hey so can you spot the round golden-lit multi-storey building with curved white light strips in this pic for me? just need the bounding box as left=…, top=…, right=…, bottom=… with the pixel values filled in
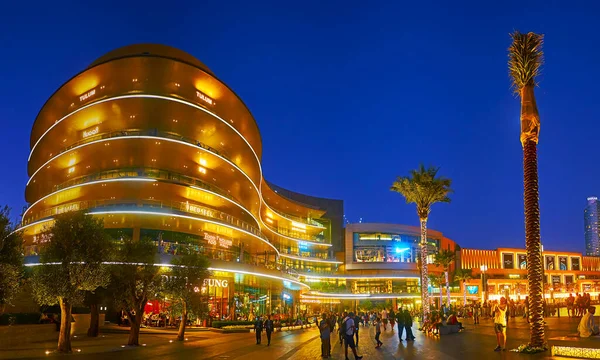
left=21, top=44, right=341, bottom=318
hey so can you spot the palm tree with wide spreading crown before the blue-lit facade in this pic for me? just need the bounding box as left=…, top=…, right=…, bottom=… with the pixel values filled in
left=390, top=164, right=452, bottom=321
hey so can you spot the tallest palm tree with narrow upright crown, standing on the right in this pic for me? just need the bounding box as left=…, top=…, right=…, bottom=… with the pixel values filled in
left=508, top=31, right=546, bottom=348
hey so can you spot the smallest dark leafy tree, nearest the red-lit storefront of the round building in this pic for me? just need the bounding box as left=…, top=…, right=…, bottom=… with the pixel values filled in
left=165, top=251, right=210, bottom=341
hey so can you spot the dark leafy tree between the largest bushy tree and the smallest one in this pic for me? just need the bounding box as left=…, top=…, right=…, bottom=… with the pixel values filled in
left=111, top=238, right=162, bottom=346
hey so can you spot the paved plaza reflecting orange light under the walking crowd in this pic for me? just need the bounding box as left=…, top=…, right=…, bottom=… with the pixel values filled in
left=0, top=317, right=592, bottom=360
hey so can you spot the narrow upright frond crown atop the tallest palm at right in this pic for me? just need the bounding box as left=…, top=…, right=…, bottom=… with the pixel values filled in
left=508, top=31, right=544, bottom=93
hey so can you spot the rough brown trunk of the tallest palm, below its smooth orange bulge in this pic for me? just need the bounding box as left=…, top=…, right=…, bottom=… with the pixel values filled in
left=523, top=140, right=546, bottom=347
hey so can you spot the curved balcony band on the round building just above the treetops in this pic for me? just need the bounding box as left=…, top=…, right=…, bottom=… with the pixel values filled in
left=22, top=200, right=270, bottom=243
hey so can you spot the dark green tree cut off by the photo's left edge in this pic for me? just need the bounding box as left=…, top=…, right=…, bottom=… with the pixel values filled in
left=0, top=206, right=23, bottom=315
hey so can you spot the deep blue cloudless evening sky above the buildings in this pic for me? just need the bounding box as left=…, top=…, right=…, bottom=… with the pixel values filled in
left=0, top=1, right=600, bottom=251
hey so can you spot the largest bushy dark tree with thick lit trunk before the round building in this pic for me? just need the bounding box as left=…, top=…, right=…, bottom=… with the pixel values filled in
left=32, top=211, right=112, bottom=352
